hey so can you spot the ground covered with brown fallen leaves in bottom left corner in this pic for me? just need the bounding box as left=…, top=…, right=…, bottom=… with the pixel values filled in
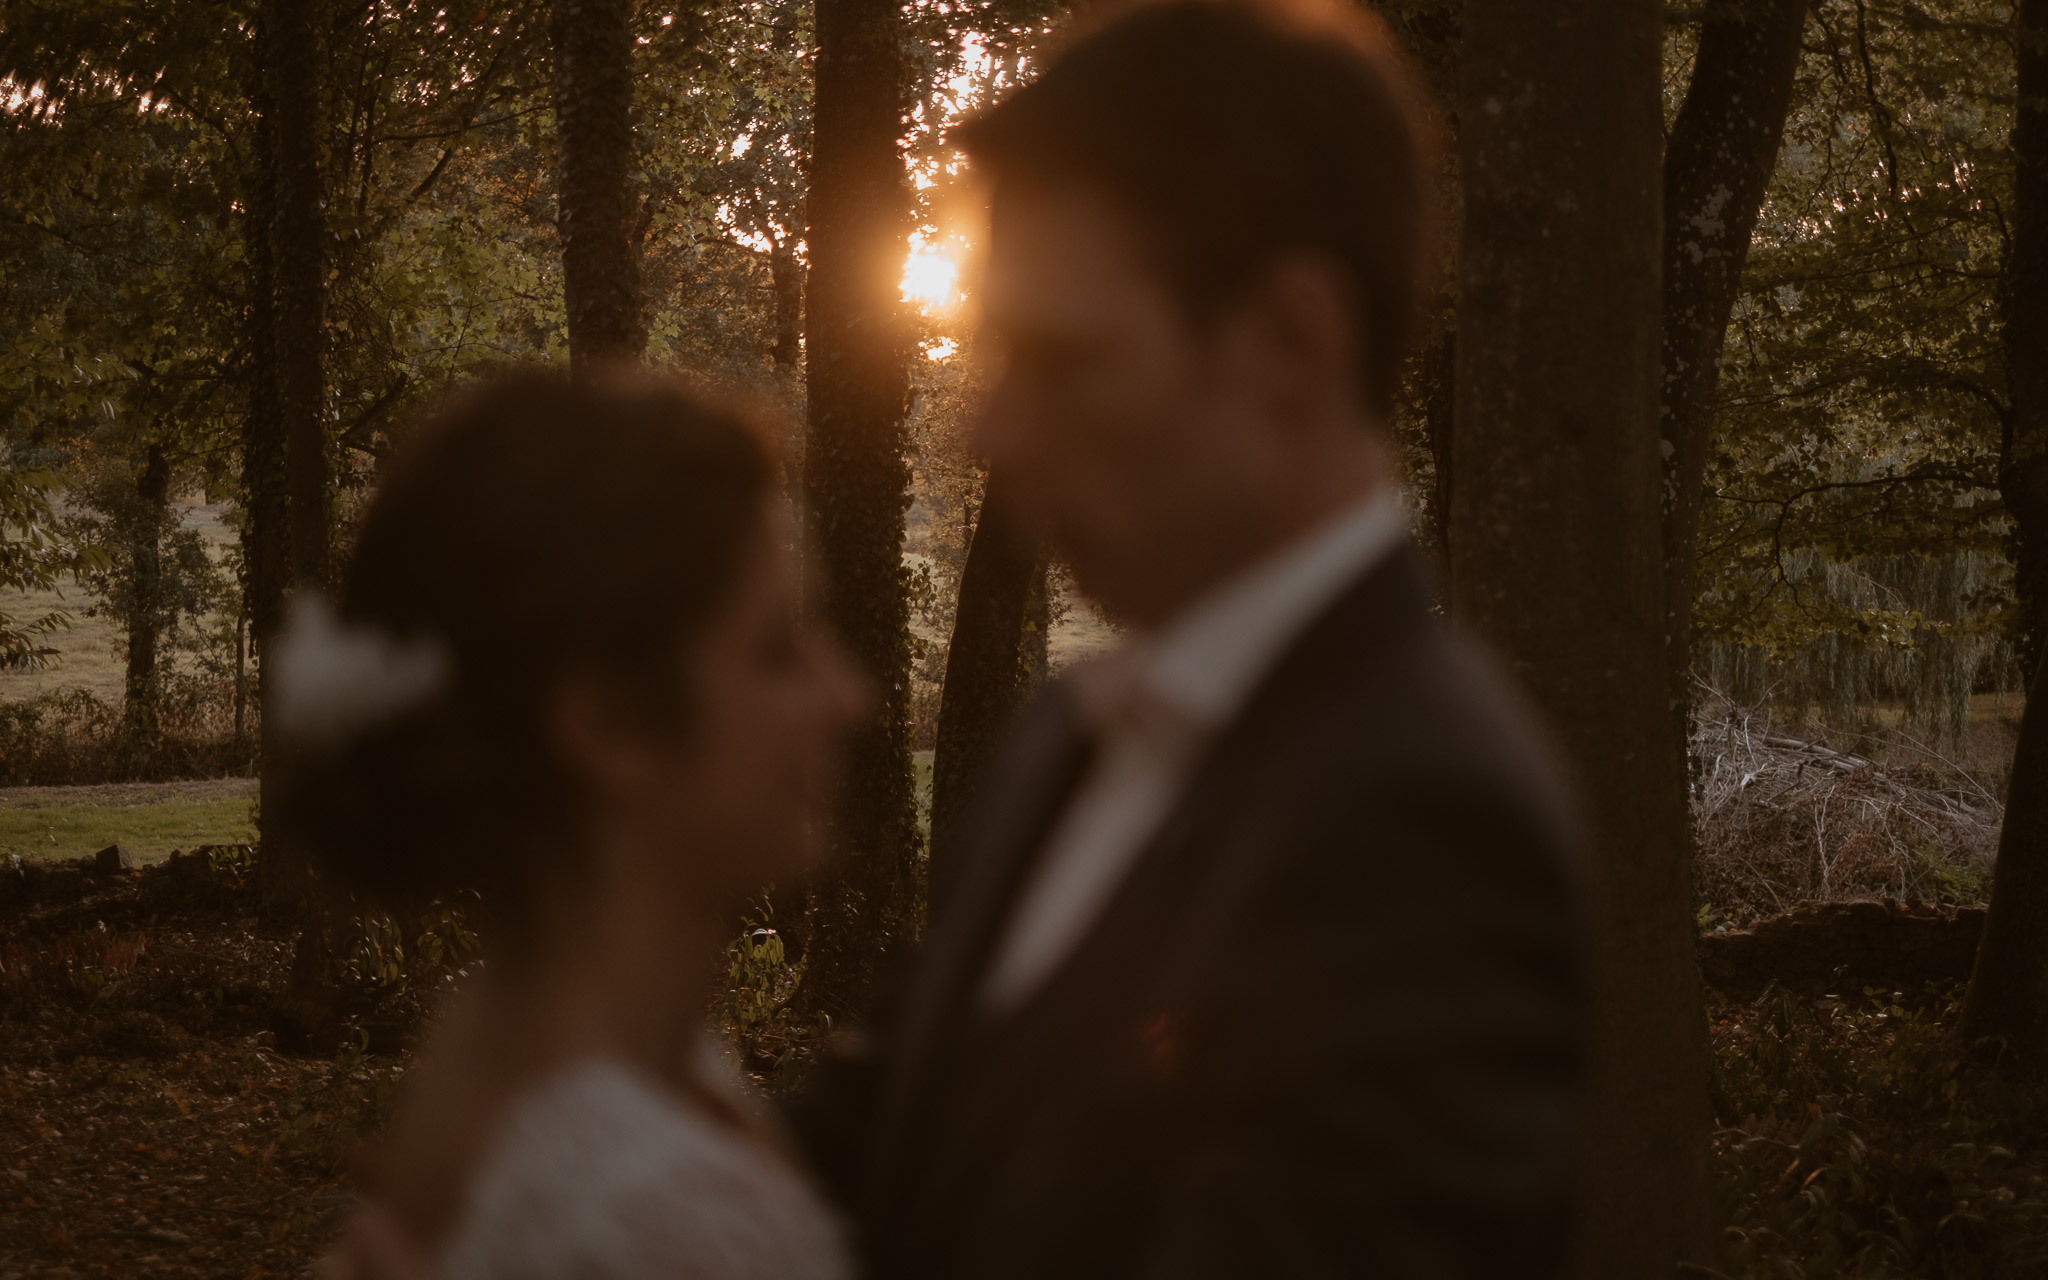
left=0, top=851, right=403, bottom=1280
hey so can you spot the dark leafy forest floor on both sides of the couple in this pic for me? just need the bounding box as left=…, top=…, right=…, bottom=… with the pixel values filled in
left=0, top=856, right=2048, bottom=1280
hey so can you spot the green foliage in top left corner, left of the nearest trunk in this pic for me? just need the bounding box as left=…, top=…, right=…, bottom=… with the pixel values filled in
left=0, top=0, right=246, bottom=491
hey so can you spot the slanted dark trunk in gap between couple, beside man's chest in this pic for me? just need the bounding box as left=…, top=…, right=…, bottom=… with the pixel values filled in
left=932, top=471, right=1044, bottom=895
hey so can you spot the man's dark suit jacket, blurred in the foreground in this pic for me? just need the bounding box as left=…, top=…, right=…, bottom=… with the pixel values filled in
left=793, top=547, right=1581, bottom=1280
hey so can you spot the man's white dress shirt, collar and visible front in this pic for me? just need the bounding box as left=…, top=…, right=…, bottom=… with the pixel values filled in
left=981, top=492, right=1407, bottom=1012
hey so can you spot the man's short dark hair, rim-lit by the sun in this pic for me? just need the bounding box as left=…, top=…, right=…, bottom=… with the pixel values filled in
left=956, top=0, right=1434, bottom=416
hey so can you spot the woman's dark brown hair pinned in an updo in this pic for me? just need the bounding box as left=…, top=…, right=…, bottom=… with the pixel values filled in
left=279, top=373, right=774, bottom=926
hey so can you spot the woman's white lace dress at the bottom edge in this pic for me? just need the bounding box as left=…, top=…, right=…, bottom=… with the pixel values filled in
left=440, top=1061, right=854, bottom=1280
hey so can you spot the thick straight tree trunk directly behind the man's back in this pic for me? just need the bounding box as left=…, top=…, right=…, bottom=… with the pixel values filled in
left=1452, top=0, right=1714, bottom=1278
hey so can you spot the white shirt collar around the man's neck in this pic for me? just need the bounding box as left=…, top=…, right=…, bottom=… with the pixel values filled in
left=1143, top=489, right=1407, bottom=729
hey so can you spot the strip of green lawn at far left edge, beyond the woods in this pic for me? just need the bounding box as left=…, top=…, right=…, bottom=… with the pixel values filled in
left=0, top=778, right=256, bottom=862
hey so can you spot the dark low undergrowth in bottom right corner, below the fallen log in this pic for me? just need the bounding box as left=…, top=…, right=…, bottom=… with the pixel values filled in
left=1712, top=987, right=2048, bottom=1280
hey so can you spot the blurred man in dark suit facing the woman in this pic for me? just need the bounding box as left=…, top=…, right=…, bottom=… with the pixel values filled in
left=797, top=0, right=1581, bottom=1280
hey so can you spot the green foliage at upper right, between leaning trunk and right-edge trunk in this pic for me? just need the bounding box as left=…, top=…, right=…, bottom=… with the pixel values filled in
left=1671, top=0, right=2017, bottom=733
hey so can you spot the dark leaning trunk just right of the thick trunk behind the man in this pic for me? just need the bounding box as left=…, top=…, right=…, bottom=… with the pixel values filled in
left=1661, top=0, right=1810, bottom=700
